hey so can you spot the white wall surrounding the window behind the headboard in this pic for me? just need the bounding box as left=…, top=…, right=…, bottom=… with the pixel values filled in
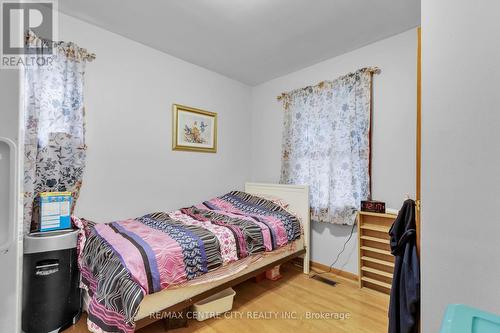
left=251, top=29, right=417, bottom=274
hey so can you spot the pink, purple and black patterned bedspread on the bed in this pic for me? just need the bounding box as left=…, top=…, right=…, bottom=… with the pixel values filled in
left=75, top=191, right=301, bottom=332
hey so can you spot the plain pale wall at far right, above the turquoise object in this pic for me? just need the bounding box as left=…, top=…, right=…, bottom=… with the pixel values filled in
left=422, top=0, right=500, bottom=332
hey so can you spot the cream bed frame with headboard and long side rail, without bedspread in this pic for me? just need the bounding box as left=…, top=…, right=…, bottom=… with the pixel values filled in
left=79, top=183, right=310, bottom=332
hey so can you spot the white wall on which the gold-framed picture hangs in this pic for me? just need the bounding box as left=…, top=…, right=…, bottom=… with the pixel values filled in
left=59, top=14, right=251, bottom=221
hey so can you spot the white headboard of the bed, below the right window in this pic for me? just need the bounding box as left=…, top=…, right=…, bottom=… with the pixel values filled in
left=245, top=183, right=311, bottom=274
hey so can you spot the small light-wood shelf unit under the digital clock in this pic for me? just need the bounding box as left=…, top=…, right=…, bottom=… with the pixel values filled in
left=358, top=212, right=397, bottom=294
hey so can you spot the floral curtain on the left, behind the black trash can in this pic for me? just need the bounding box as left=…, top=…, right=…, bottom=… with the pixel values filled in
left=24, top=32, right=95, bottom=233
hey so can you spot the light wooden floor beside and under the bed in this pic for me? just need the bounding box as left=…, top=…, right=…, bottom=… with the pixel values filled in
left=65, top=264, right=389, bottom=333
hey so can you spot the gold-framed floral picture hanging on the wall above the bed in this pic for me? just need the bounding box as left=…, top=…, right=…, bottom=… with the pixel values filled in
left=172, top=104, right=217, bottom=153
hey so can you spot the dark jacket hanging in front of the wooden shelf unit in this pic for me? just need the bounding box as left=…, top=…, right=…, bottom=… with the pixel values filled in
left=389, top=200, right=420, bottom=333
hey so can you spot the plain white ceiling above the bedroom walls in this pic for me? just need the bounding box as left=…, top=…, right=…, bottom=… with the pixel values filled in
left=59, top=0, right=420, bottom=85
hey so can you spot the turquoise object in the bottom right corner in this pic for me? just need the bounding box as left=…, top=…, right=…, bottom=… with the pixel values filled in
left=440, top=304, right=500, bottom=333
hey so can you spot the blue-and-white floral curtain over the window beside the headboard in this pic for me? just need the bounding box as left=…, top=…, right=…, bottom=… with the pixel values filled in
left=281, top=68, right=376, bottom=225
